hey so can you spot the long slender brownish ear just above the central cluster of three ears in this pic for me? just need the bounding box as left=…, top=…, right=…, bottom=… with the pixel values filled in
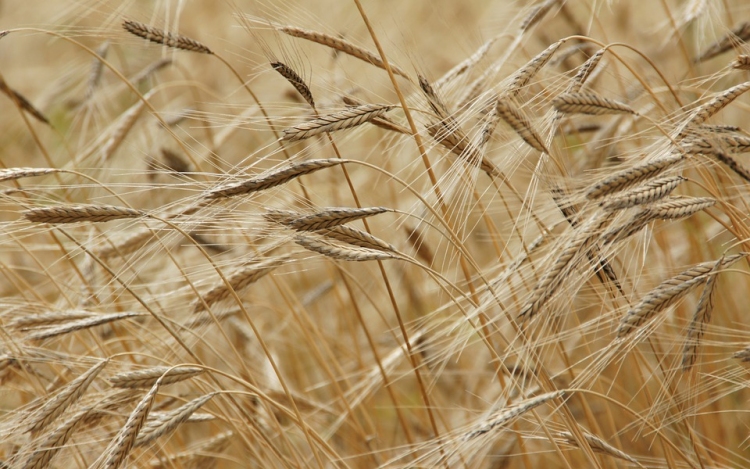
left=206, top=158, right=346, bottom=199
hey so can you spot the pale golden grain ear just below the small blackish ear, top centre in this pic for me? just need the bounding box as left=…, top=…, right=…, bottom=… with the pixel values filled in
left=282, top=104, right=393, bottom=142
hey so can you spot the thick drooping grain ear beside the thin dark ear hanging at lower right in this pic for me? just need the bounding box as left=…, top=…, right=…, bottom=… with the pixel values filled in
left=617, top=253, right=747, bottom=338
